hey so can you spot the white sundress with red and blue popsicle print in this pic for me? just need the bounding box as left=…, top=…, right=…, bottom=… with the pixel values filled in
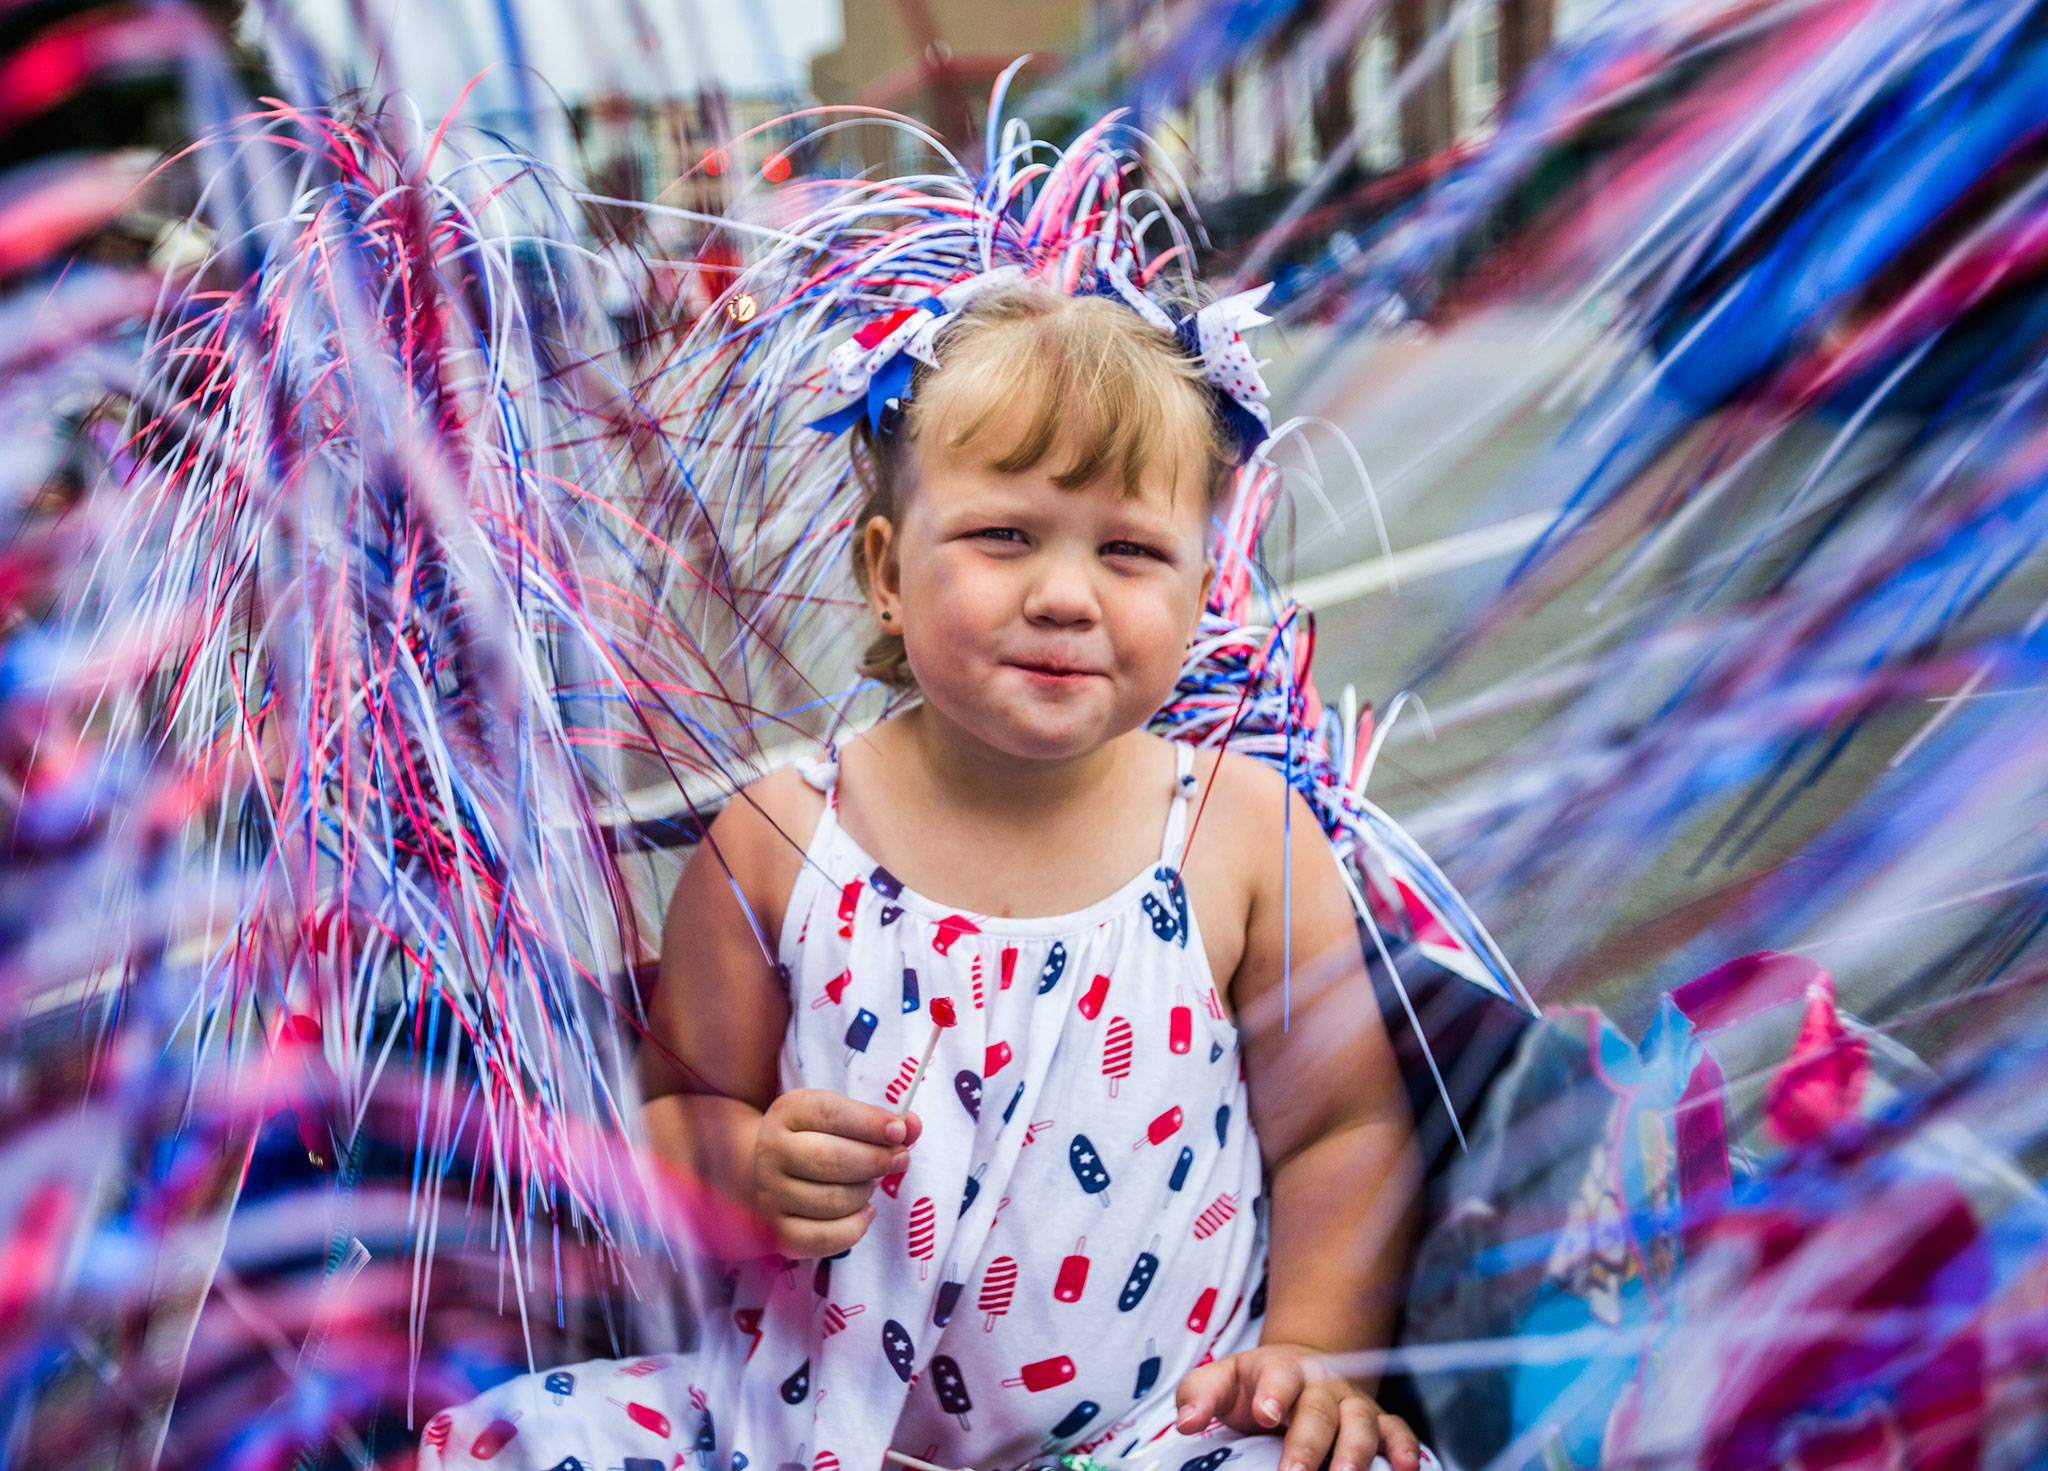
left=422, top=746, right=1433, bottom=1471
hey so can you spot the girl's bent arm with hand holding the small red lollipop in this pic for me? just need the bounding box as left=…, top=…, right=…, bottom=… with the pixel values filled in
left=641, top=772, right=918, bottom=1256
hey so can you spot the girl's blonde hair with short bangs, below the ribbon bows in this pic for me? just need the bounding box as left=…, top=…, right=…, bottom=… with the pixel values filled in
left=852, top=283, right=1237, bottom=690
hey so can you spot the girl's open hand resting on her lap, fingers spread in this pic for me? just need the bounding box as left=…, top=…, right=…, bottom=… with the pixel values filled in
left=1176, top=1344, right=1421, bottom=1471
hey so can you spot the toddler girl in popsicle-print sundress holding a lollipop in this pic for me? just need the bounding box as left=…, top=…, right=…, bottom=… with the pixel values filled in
left=424, top=115, right=1434, bottom=1471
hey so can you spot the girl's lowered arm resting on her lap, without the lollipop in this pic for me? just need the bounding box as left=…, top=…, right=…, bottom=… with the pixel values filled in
left=1180, top=762, right=1419, bottom=1471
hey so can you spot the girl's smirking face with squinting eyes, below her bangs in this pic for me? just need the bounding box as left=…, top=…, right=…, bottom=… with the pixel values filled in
left=866, top=424, right=1210, bottom=760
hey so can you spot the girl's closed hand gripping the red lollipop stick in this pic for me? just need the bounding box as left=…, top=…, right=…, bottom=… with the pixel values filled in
left=754, top=1088, right=924, bottom=1258
